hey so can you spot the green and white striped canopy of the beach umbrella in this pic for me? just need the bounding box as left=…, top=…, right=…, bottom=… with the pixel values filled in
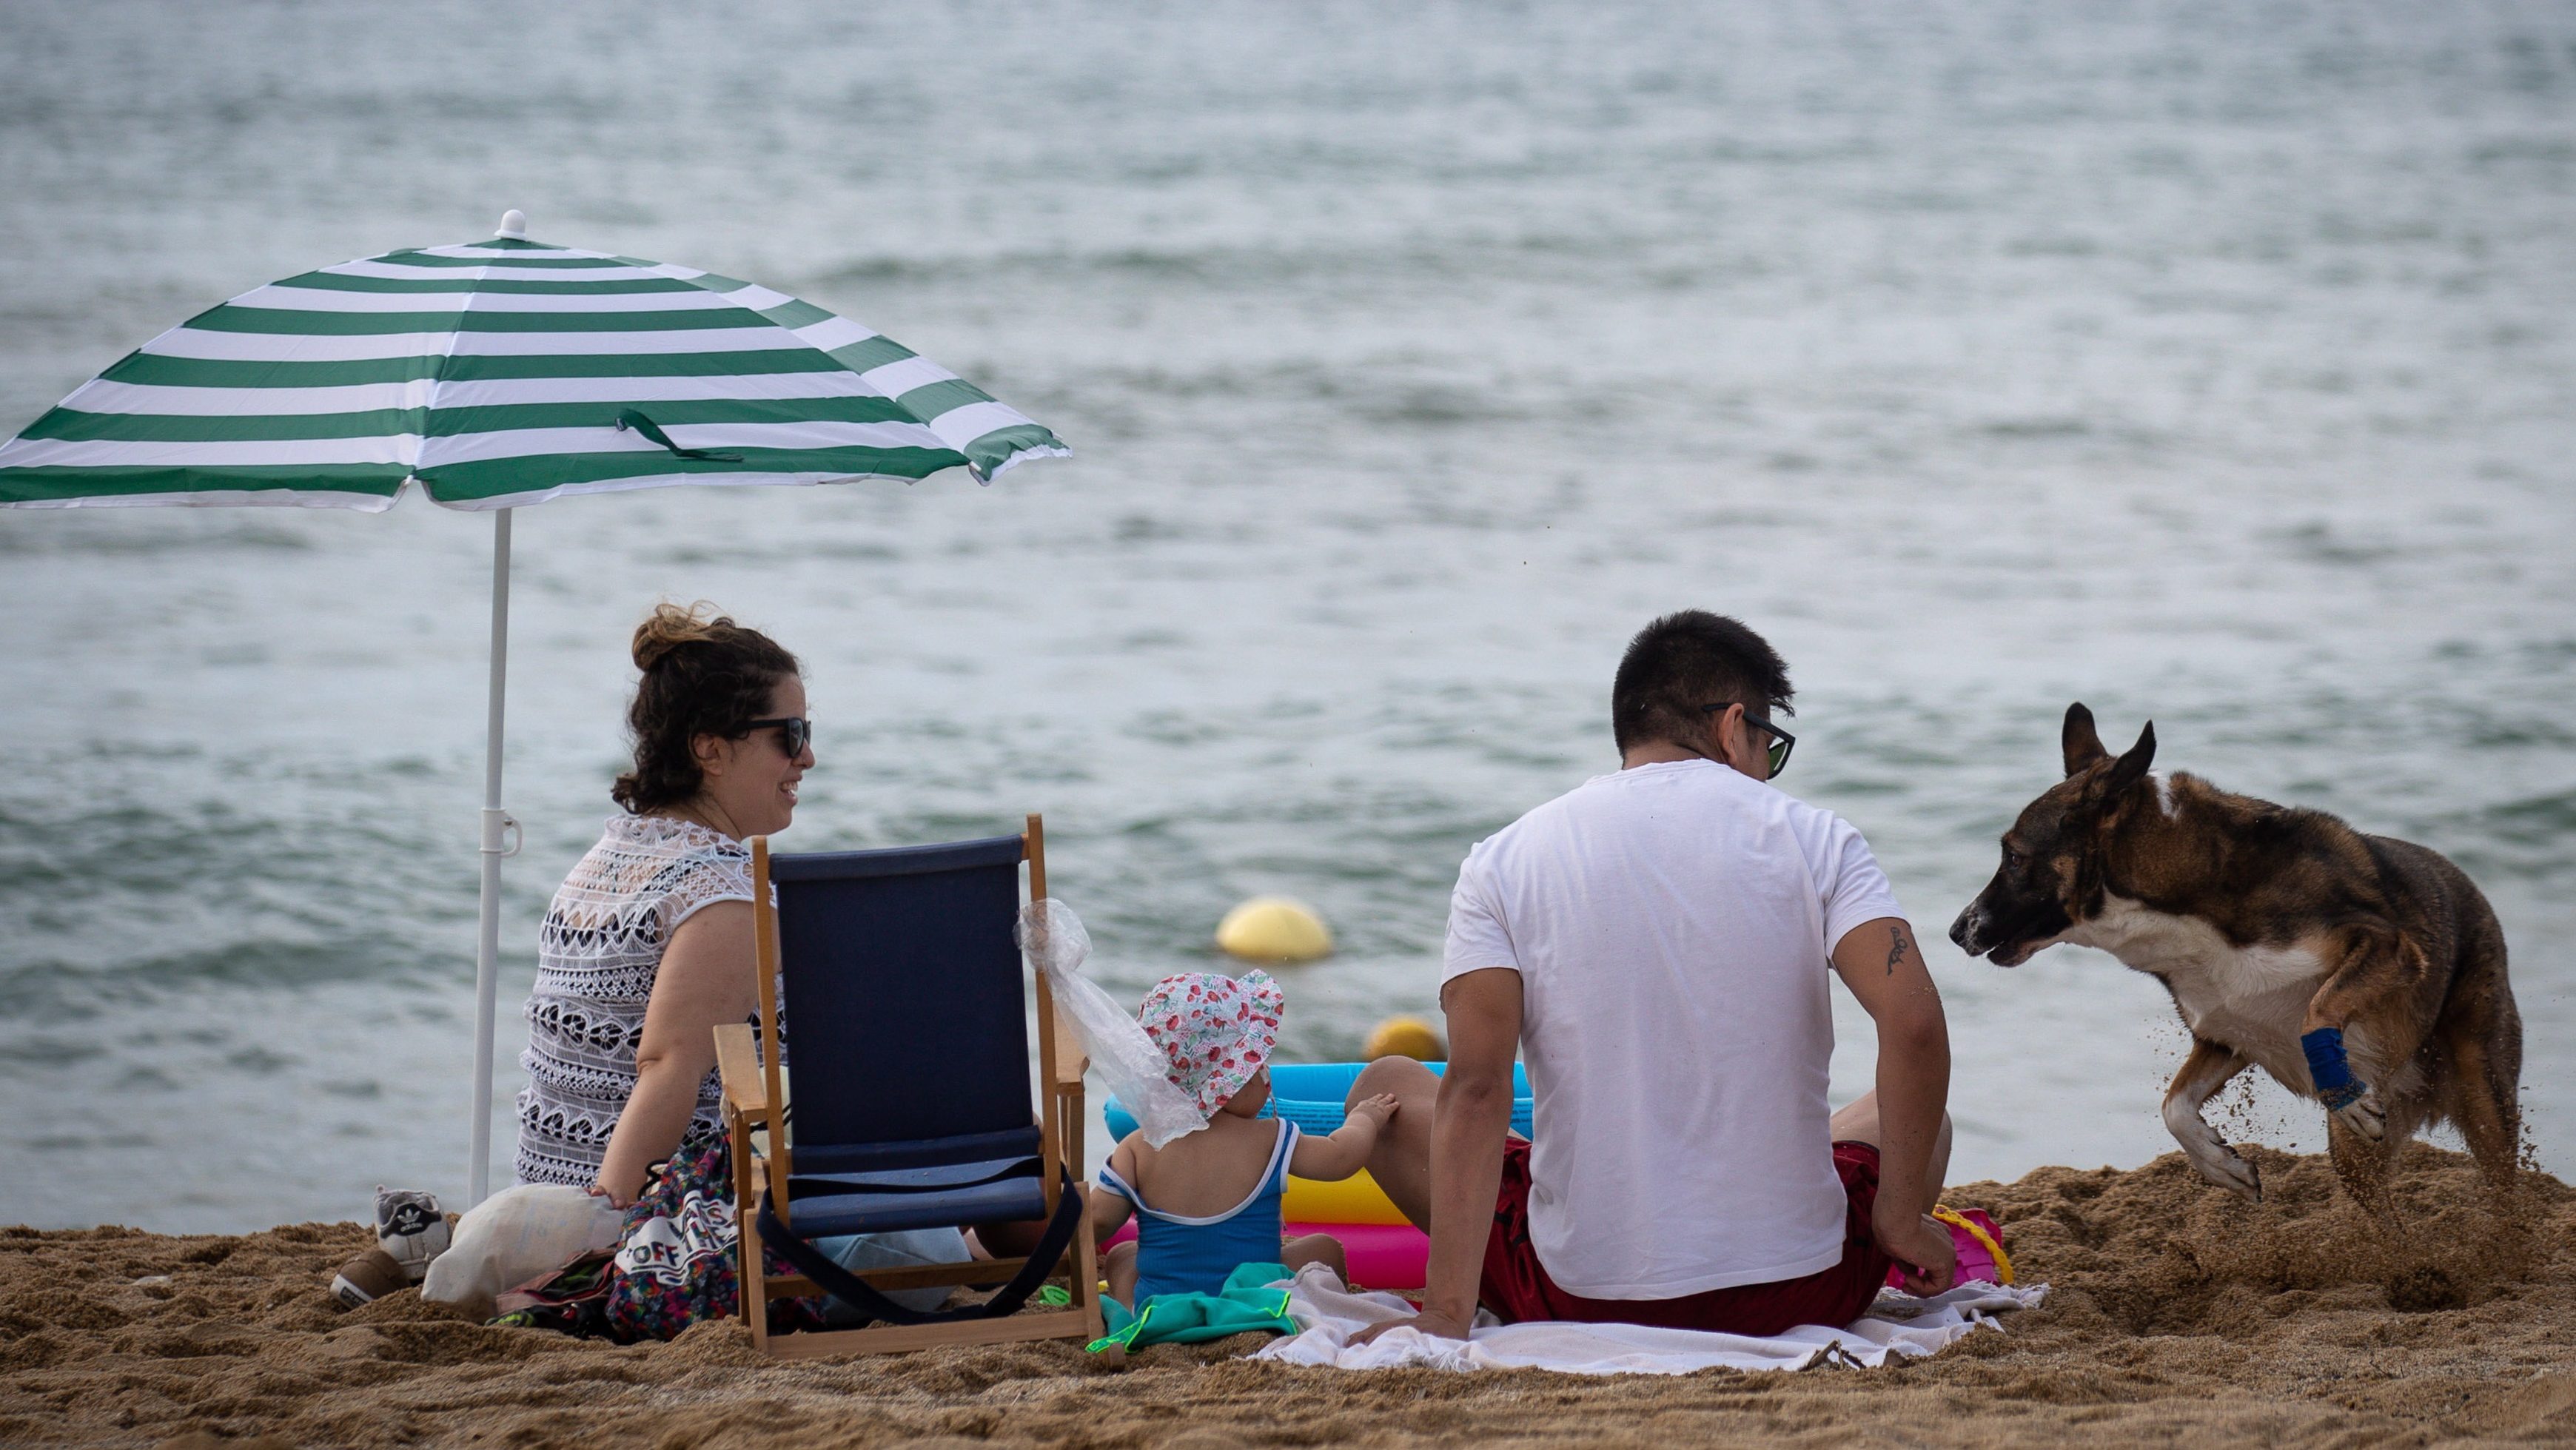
left=0, top=237, right=1069, bottom=510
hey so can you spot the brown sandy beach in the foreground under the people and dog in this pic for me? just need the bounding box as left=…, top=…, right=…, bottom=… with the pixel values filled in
left=0, top=1146, right=2576, bottom=1450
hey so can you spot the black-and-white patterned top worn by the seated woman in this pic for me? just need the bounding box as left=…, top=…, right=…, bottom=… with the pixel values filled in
left=517, top=816, right=752, bottom=1185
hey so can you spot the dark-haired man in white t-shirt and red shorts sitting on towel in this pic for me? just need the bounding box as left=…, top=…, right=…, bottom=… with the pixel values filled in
left=1352, top=611, right=1955, bottom=1337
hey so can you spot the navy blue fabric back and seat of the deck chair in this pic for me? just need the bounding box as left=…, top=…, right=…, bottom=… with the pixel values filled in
left=771, top=837, right=1046, bottom=1236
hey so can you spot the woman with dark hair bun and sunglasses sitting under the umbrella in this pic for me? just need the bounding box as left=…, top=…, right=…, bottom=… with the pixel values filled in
left=517, top=603, right=814, bottom=1208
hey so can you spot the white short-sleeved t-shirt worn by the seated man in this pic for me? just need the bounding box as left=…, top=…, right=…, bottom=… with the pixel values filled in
left=1440, top=759, right=1904, bottom=1298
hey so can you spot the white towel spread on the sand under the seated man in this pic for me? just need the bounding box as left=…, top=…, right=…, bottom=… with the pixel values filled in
left=1252, top=1264, right=2048, bottom=1375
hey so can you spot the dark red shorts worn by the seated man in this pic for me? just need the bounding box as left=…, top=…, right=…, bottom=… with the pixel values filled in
left=1476, top=1138, right=1888, bottom=1334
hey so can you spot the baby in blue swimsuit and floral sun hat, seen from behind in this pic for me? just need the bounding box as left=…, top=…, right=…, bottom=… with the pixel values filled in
left=1093, top=971, right=1396, bottom=1306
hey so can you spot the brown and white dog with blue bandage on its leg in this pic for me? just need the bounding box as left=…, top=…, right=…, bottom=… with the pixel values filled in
left=1950, top=705, right=2522, bottom=1210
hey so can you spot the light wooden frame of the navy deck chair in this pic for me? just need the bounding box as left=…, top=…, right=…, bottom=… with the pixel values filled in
left=716, top=816, right=1105, bottom=1360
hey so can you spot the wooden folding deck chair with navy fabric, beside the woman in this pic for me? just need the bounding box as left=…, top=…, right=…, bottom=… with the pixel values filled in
left=716, top=816, right=1102, bottom=1357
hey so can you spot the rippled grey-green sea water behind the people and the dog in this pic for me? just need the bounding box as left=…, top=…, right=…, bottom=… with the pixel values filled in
left=0, top=0, right=2576, bottom=1229
